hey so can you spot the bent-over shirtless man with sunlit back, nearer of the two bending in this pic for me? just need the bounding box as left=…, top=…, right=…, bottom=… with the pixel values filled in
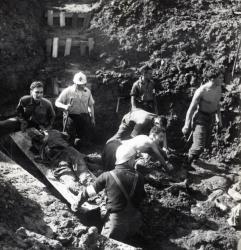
left=101, top=126, right=168, bottom=171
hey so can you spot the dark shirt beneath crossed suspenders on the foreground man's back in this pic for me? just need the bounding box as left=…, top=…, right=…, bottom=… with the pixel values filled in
left=93, top=164, right=146, bottom=213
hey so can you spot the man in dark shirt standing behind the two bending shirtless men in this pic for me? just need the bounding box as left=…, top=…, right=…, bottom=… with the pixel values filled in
left=130, top=65, right=155, bottom=112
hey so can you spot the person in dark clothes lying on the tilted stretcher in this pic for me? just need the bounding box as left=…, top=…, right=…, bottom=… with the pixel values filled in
left=28, top=129, right=91, bottom=193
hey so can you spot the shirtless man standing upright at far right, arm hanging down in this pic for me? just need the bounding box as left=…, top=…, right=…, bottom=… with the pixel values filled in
left=182, top=68, right=223, bottom=166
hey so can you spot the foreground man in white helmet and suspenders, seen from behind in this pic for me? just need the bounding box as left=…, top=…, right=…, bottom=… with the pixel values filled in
left=71, top=145, right=145, bottom=241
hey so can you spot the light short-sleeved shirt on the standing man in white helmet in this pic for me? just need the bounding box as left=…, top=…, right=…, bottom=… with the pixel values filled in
left=58, top=85, right=94, bottom=115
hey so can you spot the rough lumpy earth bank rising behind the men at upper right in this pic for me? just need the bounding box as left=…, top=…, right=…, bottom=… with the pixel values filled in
left=91, top=0, right=241, bottom=161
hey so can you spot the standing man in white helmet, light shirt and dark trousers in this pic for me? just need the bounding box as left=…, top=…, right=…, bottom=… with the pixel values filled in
left=55, top=72, right=95, bottom=145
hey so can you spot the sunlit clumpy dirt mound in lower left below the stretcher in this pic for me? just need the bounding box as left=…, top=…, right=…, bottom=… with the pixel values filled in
left=0, top=153, right=119, bottom=249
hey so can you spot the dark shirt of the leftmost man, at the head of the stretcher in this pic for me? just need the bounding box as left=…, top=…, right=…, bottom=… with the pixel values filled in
left=17, top=95, right=55, bottom=127
